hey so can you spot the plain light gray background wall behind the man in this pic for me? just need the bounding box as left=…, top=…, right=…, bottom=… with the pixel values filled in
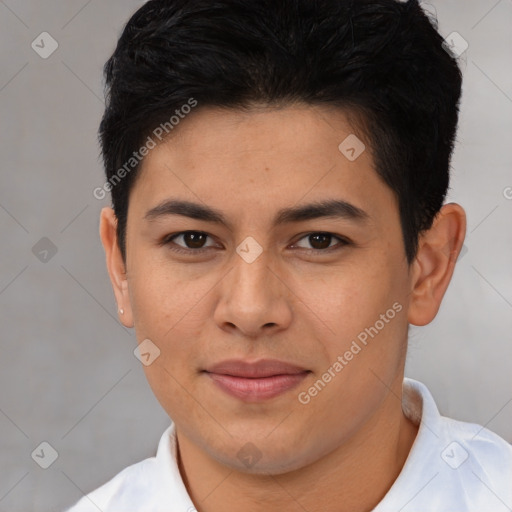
left=0, top=0, right=512, bottom=512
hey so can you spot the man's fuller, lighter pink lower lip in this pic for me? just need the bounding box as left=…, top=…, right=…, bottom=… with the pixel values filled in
left=207, top=372, right=309, bottom=402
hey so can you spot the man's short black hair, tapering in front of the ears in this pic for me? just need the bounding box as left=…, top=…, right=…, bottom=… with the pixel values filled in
left=99, top=0, right=462, bottom=264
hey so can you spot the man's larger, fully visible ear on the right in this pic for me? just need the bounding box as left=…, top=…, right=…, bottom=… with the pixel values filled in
left=408, top=203, right=466, bottom=325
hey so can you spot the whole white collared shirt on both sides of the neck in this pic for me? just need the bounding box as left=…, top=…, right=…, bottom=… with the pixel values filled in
left=67, top=378, right=512, bottom=512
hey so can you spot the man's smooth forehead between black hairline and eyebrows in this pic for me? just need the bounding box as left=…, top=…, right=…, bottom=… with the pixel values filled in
left=130, top=106, right=394, bottom=226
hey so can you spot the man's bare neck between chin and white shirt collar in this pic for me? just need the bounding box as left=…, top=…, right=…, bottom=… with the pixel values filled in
left=177, top=381, right=418, bottom=512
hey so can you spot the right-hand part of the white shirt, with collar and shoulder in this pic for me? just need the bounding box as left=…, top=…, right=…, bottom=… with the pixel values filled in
left=374, top=379, right=512, bottom=512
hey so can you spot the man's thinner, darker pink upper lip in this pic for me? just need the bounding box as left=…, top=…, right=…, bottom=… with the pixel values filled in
left=205, top=359, right=308, bottom=379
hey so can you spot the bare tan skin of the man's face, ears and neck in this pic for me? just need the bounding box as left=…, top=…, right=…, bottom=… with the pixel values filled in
left=100, top=105, right=466, bottom=512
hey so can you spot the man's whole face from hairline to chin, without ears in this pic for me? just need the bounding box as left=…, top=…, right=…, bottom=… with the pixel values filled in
left=119, top=106, right=410, bottom=472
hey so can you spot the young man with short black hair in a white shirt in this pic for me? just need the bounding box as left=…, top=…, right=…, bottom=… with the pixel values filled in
left=71, top=0, right=512, bottom=512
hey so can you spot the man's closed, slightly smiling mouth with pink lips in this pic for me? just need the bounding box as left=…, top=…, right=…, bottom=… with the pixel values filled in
left=204, top=359, right=311, bottom=402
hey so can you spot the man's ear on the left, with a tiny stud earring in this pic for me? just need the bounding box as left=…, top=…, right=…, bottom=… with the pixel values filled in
left=100, top=207, right=133, bottom=327
